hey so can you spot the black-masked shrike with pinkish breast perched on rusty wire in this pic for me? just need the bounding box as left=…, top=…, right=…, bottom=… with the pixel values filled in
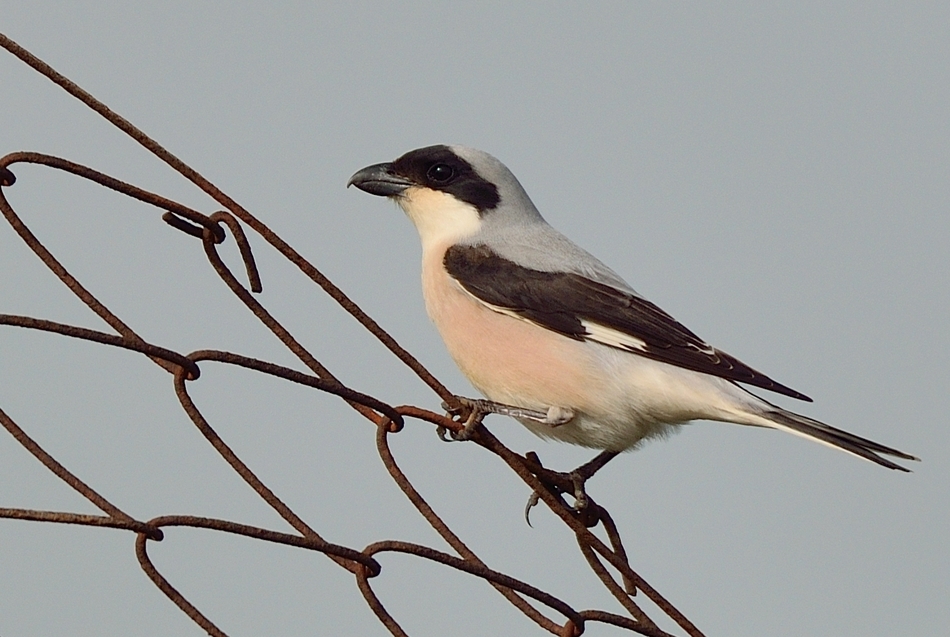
left=349, top=145, right=917, bottom=471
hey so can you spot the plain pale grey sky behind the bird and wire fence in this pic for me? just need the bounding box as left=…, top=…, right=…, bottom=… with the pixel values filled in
left=0, top=0, right=950, bottom=637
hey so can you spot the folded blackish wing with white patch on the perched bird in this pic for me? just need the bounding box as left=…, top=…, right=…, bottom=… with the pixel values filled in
left=444, top=245, right=811, bottom=402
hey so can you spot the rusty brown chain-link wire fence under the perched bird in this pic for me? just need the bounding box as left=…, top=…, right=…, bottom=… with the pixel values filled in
left=0, top=34, right=702, bottom=637
